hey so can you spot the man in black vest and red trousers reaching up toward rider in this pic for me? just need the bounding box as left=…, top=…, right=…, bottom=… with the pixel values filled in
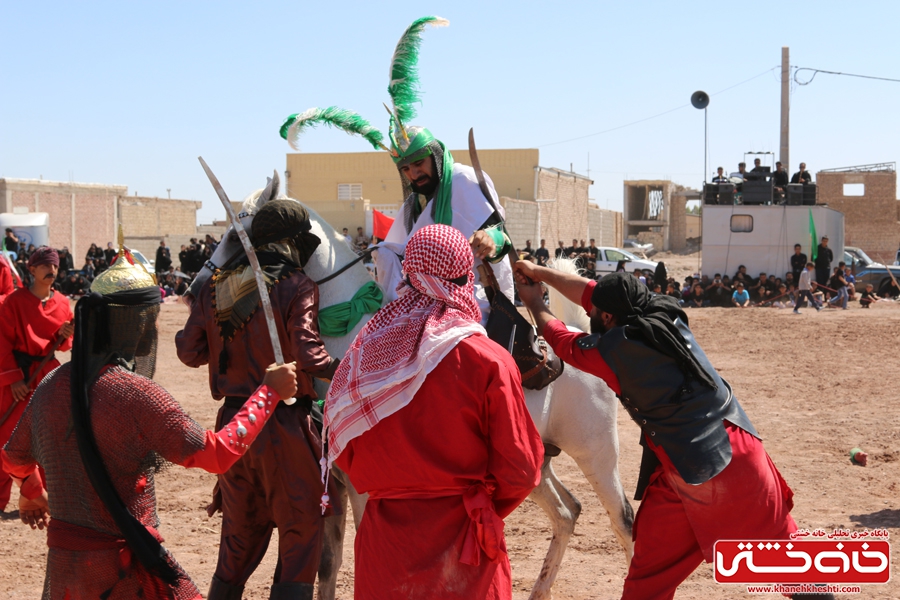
left=516, top=261, right=833, bottom=600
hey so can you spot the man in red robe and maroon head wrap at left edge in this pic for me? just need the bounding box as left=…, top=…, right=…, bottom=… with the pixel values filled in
left=0, top=246, right=74, bottom=510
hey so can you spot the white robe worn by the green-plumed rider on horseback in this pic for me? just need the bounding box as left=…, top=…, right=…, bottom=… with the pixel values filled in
left=375, top=163, right=514, bottom=325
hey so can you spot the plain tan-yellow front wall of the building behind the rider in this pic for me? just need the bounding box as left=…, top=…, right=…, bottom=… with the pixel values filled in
left=287, top=148, right=538, bottom=204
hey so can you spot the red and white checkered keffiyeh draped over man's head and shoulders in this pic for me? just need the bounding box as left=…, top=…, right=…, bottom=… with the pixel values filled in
left=323, top=225, right=486, bottom=469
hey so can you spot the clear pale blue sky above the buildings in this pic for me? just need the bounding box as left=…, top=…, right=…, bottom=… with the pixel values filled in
left=0, top=0, right=900, bottom=222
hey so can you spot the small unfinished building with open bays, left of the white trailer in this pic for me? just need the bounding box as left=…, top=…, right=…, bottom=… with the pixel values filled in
left=623, top=180, right=700, bottom=252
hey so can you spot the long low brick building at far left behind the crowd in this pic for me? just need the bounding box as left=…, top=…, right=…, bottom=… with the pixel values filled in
left=0, top=179, right=202, bottom=268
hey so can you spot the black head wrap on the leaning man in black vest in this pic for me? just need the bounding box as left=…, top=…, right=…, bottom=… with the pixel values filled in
left=591, top=273, right=717, bottom=389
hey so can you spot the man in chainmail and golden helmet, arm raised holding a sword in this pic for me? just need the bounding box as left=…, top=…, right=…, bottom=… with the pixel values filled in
left=2, top=246, right=297, bottom=600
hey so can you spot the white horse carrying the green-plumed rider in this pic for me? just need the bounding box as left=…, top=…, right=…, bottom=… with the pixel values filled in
left=191, top=172, right=634, bottom=600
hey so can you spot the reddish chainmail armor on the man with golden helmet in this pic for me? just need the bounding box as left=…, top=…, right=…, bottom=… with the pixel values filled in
left=7, top=364, right=205, bottom=600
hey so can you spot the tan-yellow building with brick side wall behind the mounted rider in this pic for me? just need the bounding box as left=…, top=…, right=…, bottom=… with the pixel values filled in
left=286, top=148, right=622, bottom=248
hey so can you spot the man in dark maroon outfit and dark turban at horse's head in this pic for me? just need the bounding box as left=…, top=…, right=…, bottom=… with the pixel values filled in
left=175, top=200, right=336, bottom=600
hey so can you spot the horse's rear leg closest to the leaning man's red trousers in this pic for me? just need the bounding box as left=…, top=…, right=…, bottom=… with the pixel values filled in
left=572, top=444, right=634, bottom=566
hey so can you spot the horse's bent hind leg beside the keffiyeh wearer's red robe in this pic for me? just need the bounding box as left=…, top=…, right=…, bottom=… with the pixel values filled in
left=529, top=456, right=581, bottom=600
